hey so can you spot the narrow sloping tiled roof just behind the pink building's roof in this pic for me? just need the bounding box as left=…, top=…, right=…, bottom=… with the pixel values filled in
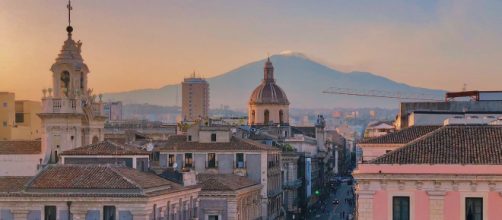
left=359, top=125, right=441, bottom=144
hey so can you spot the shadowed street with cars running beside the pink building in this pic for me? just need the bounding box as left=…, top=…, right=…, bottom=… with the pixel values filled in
left=308, top=183, right=354, bottom=220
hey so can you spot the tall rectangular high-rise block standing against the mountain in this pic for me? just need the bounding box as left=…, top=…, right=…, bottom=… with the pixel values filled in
left=181, top=75, right=209, bottom=121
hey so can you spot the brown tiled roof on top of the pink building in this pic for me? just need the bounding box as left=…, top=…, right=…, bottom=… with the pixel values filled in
left=370, top=125, right=502, bottom=165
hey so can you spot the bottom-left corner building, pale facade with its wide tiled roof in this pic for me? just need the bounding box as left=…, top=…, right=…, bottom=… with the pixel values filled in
left=0, top=165, right=200, bottom=220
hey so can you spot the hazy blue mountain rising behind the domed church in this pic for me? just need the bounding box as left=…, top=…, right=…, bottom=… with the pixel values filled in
left=104, top=53, right=445, bottom=109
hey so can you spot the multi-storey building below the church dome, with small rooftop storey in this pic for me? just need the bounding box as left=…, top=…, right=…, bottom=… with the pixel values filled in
left=154, top=125, right=283, bottom=219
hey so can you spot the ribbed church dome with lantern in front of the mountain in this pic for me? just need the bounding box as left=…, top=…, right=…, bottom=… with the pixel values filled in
left=249, top=58, right=289, bottom=105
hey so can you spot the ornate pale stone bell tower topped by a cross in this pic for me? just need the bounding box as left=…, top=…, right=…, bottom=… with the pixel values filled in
left=39, top=2, right=106, bottom=164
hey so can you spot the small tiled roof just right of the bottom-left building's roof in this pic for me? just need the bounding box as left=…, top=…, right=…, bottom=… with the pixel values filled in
left=197, top=174, right=259, bottom=191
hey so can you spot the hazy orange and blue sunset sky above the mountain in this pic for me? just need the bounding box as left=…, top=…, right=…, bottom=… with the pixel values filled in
left=0, top=0, right=502, bottom=99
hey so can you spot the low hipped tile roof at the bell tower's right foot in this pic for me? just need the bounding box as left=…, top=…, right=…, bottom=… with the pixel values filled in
left=61, top=141, right=150, bottom=155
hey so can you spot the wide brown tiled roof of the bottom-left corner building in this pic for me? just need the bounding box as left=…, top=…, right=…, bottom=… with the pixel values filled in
left=0, top=164, right=194, bottom=197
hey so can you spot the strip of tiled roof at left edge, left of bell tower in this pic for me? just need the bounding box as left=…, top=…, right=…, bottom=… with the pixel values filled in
left=0, top=140, right=42, bottom=154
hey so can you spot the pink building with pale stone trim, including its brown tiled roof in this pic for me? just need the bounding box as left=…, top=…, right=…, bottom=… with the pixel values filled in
left=354, top=125, right=502, bottom=220
